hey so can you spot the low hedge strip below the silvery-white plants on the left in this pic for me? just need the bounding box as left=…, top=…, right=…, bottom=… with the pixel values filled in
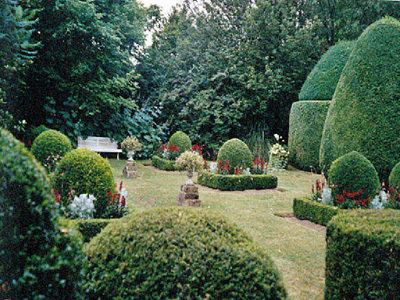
left=59, top=218, right=116, bottom=243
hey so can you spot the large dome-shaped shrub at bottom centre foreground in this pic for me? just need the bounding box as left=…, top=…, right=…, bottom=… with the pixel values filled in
left=85, top=208, right=286, bottom=300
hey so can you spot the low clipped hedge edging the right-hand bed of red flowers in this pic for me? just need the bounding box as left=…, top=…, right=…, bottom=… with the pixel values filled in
left=293, top=198, right=341, bottom=226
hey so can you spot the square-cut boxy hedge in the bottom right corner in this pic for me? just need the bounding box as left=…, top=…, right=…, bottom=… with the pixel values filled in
left=325, top=210, right=400, bottom=300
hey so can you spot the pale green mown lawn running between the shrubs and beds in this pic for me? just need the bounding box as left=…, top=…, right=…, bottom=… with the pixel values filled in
left=110, top=160, right=325, bottom=300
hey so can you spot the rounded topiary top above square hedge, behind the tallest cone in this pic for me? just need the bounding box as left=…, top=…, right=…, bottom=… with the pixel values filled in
left=299, top=41, right=355, bottom=101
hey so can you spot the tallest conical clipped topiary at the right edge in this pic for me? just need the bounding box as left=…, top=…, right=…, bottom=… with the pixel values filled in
left=320, top=18, right=400, bottom=181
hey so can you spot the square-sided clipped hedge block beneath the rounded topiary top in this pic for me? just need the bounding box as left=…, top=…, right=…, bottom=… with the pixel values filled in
left=289, top=101, right=330, bottom=171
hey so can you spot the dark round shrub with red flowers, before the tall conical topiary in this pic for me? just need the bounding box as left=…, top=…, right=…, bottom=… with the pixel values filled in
left=329, top=151, right=379, bottom=208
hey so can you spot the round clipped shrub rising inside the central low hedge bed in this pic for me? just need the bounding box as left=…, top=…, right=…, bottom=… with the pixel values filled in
left=217, top=139, right=252, bottom=174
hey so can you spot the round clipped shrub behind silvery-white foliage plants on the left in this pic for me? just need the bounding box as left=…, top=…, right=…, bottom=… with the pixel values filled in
left=54, top=148, right=115, bottom=217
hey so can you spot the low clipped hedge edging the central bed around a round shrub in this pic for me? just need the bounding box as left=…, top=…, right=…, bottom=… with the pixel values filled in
left=197, top=171, right=278, bottom=191
